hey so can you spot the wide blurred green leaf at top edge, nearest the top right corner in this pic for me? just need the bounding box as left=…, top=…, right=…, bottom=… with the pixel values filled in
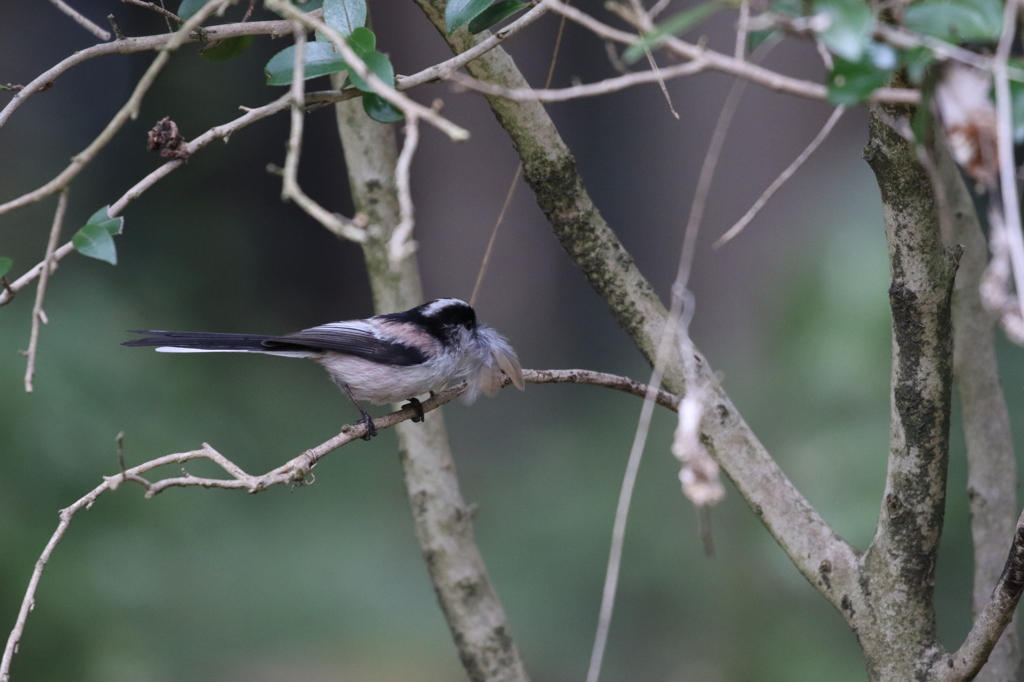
left=904, top=0, right=1002, bottom=43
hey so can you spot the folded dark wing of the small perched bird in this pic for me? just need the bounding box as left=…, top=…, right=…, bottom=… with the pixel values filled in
left=263, top=321, right=427, bottom=367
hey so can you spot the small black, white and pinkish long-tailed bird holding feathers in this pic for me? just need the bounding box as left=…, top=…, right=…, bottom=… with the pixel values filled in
left=122, top=298, right=524, bottom=440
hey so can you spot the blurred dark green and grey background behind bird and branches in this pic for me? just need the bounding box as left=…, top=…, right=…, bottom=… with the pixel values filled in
left=0, top=0, right=1024, bottom=682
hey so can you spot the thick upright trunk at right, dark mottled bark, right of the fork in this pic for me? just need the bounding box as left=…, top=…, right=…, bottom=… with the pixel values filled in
left=858, top=107, right=959, bottom=679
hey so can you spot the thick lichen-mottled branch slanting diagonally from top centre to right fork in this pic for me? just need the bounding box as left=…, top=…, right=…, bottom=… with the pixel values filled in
left=417, top=0, right=863, bottom=622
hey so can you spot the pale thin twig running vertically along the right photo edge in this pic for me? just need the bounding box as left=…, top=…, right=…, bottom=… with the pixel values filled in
left=992, top=0, right=1024, bottom=323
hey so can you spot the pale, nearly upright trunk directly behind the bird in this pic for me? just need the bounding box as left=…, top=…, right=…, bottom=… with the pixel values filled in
left=332, top=87, right=528, bottom=682
